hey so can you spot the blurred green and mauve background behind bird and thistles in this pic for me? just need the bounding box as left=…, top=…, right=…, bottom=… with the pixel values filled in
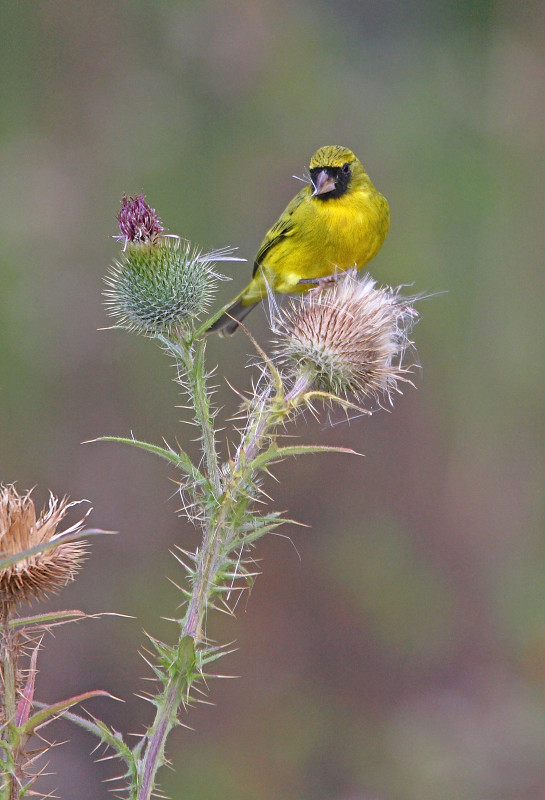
left=0, top=0, right=545, bottom=800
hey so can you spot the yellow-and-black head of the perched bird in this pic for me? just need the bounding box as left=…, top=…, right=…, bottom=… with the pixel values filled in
left=309, top=145, right=367, bottom=200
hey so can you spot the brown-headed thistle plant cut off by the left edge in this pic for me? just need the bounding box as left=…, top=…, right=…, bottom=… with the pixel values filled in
left=0, top=485, right=107, bottom=800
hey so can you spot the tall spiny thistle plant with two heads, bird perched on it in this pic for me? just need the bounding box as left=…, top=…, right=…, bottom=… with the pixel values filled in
left=61, top=195, right=417, bottom=800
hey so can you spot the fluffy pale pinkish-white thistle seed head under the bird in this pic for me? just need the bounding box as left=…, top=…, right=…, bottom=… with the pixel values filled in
left=277, top=273, right=418, bottom=399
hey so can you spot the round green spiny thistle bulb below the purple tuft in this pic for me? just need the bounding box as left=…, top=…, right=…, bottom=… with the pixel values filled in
left=104, top=239, right=216, bottom=336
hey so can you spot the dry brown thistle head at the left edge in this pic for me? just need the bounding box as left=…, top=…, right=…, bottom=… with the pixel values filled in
left=0, top=486, right=86, bottom=611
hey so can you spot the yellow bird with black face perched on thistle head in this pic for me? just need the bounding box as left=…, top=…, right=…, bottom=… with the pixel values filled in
left=210, top=145, right=390, bottom=336
